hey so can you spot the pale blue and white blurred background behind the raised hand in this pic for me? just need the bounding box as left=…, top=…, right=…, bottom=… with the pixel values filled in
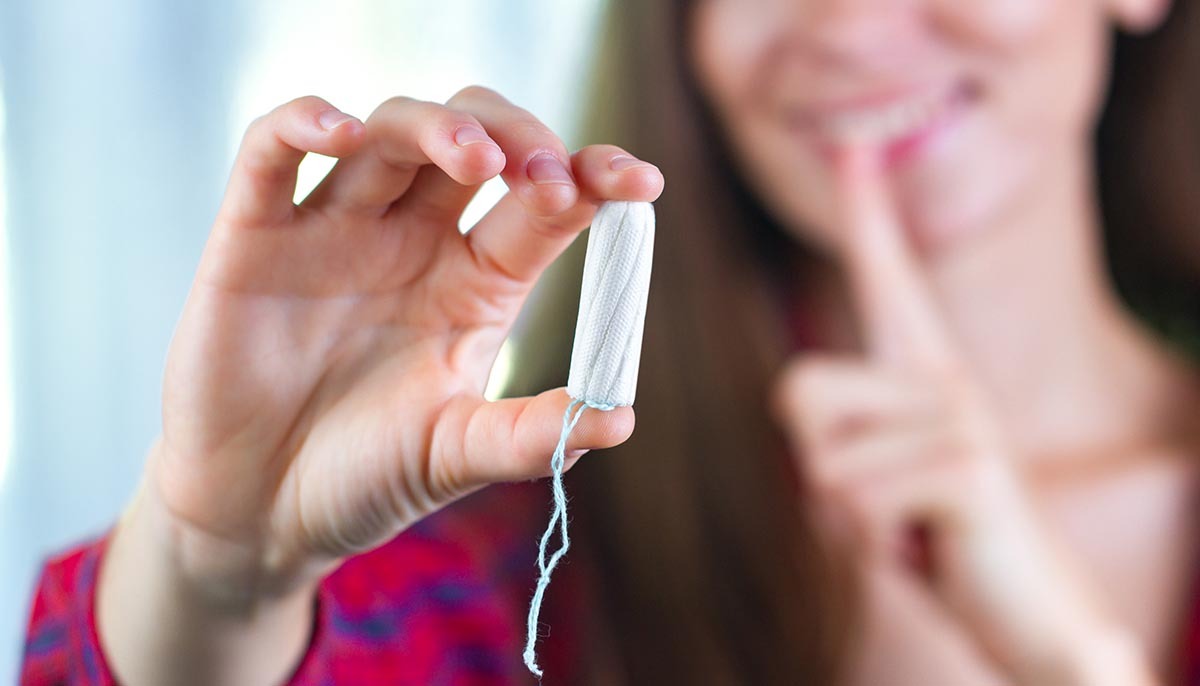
left=0, top=0, right=600, bottom=684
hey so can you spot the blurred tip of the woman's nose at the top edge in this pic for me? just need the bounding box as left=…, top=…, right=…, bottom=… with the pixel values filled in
left=793, top=0, right=921, bottom=68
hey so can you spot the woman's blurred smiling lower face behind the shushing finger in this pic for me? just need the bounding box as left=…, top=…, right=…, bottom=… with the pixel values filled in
left=690, top=0, right=1166, bottom=248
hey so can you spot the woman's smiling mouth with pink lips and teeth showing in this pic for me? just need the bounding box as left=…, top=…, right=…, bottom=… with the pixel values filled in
left=791, top=83, right=976, bottom=158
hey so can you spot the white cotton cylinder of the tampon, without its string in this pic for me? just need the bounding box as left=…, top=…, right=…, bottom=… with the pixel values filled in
left=566, top=200, right=654, bottom=407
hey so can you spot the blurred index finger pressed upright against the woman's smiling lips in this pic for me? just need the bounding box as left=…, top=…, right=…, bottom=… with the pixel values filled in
left=834, top=146, right=953, bottom=367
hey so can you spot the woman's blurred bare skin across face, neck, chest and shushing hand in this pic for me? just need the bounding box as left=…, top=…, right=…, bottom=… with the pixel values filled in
left=691, top=0, right=1196, bottom=685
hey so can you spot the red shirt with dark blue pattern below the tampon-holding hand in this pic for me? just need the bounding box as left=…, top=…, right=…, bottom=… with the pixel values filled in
left=20, top=483, right=575, bottom=686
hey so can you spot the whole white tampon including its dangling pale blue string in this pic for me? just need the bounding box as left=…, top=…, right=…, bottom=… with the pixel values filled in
left=524, top=200, right=654, bottom=679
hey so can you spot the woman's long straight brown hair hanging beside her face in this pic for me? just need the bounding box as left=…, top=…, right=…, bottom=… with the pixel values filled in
left=509, top=0, right=1200, bottom=685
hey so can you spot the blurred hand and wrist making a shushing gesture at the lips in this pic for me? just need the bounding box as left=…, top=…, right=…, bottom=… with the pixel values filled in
left=779, top=151, right=1151, bottom=686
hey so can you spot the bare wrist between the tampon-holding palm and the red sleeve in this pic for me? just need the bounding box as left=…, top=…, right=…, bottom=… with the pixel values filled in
left=96, top=472, right=314, bottom=686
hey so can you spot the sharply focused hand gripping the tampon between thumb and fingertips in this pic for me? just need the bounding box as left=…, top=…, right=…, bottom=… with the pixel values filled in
left=101, top=88, right=662, bottom=684
